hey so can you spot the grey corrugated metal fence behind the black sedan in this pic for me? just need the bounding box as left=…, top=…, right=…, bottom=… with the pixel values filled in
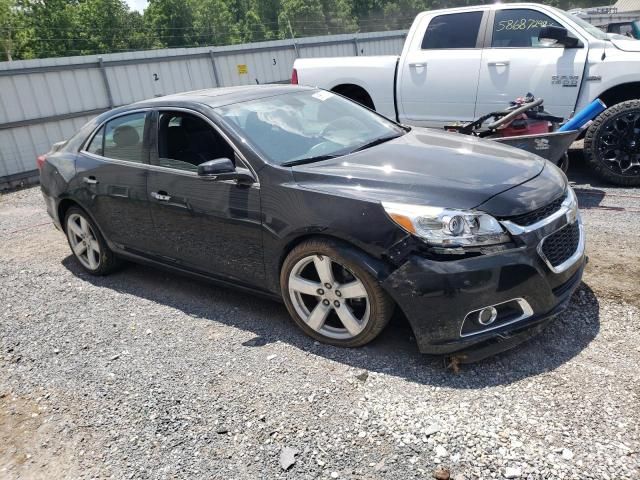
left=0, top=31, right=406, bottom=188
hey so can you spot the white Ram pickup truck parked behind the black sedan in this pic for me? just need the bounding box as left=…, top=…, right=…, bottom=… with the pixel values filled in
left=292, top=3, right=640, bottom=185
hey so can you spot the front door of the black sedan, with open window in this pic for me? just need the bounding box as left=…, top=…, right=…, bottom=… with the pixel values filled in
left=147, top=111, right=264, bottom=284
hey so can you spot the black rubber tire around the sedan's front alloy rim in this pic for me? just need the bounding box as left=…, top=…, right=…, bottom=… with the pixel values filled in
left=280, top=239, right=395, bottom=347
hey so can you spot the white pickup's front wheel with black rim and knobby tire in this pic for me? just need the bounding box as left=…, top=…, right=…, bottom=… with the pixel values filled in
left=584, top=100, right=640, bottom=186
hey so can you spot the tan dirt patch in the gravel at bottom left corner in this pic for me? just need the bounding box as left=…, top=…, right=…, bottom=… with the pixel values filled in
left=0, top=393, right=80, bottom=480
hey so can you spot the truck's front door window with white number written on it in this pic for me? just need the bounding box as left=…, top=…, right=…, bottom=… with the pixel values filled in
left=491, top=8, right=561, bottom=48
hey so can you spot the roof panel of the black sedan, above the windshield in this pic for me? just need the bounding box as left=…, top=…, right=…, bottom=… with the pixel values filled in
left=131, top=84, right=314, bottom=108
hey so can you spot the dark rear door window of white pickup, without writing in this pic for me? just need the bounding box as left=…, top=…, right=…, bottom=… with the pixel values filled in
left=422, top=12, right=482, bottom=50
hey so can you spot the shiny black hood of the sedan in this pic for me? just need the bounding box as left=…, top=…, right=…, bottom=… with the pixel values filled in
left=292, top=128, right=545, bottom=208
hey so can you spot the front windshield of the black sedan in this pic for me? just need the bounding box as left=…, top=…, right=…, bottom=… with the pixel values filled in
left=216, top=90, right=405, bottom=165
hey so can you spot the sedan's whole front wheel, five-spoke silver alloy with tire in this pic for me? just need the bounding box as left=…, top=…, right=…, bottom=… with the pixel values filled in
left=281, top=240, right=393, bottom=347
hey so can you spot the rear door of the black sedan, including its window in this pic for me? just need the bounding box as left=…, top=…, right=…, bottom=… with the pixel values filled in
left=76, top=111, right=155, bottom=251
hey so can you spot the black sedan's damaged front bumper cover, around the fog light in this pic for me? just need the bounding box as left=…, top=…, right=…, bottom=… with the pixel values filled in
left=383, top=240, right=585, bottom=358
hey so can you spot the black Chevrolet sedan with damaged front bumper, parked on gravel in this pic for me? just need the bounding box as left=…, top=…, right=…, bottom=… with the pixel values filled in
left=38, top=86, right=584, bottom=354
